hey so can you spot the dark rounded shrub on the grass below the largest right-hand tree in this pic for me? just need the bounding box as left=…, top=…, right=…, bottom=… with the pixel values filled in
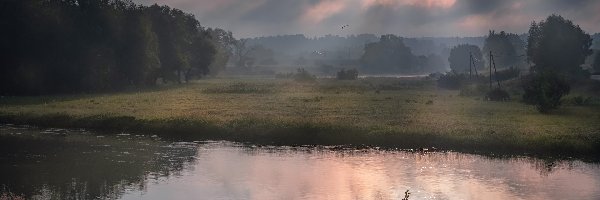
left=523, top=72, right=571, bottom=113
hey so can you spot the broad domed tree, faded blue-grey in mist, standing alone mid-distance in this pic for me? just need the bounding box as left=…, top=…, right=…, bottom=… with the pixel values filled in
left=360, top=35, right=417, bottom=73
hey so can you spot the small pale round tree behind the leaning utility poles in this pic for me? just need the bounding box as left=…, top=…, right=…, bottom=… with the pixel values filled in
left=448, top=44, right=483, bottom=73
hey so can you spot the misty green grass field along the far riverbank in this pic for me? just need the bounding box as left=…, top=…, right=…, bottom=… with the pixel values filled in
left=0, top=78, right=600, bottom=158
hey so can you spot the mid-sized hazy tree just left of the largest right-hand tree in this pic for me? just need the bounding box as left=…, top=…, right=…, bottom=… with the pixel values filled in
left=483, top=31, right=521, bottom=68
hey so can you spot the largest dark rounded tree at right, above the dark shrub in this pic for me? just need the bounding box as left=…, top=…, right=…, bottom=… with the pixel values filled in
left=527, top=15, right=592, bottom=78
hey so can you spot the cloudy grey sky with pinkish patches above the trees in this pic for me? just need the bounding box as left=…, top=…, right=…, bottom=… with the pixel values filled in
left=134, top=0, right=600, bottom=38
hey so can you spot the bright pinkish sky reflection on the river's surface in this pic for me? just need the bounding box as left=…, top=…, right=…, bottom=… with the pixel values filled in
left=125, top=143, right=600, bottom=199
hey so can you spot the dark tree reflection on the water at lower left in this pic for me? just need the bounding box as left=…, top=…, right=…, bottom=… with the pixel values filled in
left=0, top=130, right=196, bottom=199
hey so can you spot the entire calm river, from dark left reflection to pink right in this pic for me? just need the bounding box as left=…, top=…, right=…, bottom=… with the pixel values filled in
left=0, top=126, right=600, bottom=199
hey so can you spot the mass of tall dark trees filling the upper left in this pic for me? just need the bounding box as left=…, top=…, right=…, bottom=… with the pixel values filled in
left=0, top=0, right=235, bottom=95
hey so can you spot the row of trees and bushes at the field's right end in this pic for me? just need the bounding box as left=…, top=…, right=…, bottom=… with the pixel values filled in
left=438, top=15, right=600, bottom=113
